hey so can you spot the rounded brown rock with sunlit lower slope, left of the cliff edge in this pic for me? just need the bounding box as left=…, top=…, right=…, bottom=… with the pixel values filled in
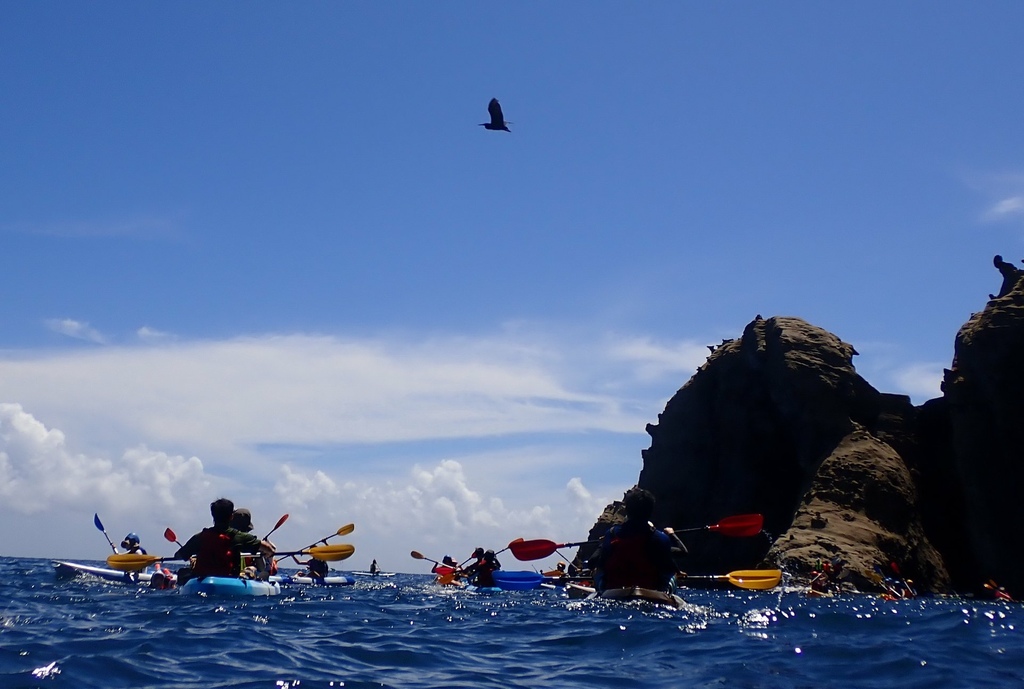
left=610, top=317, right=948, bottom=589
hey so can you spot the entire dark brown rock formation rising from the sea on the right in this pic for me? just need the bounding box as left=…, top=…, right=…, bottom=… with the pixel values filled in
left=581, top=259, right=1024, bottom=597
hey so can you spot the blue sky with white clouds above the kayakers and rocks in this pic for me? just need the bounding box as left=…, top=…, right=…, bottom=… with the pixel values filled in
left=0, top=2, right=1024, bottom=571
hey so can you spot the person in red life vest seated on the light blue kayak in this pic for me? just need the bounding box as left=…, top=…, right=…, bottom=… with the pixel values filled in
left=174, top=498, right=274, bottom=584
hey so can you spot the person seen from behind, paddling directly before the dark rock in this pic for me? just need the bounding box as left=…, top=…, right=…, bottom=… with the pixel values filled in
left=591, top=487, right=686, bottom=593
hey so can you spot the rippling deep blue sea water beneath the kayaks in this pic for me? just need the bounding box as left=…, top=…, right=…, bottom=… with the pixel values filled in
left=0, top=558, right=1024, bottom=689
